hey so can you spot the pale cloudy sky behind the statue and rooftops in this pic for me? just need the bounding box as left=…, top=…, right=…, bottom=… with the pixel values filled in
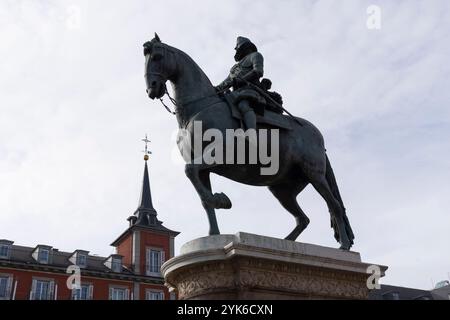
left=0, top=0, right=450, bottom=289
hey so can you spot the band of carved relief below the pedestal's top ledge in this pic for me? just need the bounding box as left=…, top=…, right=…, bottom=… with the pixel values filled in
left=167, top=258, right=368, bottom=299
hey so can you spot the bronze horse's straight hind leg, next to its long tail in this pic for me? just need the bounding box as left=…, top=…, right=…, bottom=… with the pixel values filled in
left=311, top=174, right=351, bottom=250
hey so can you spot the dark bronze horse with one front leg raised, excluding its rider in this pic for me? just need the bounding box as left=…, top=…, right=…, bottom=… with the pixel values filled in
left=144, top=34, right=354, bottom=250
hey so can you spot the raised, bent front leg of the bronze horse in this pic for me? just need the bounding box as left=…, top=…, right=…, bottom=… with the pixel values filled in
left=184, top=163, right=231, bottom=209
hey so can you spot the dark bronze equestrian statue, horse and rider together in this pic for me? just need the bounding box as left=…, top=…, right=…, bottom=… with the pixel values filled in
left=144, top=34, right=354, bottom=250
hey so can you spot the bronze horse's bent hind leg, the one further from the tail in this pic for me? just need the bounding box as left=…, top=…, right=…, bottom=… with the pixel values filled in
left=269, top=181, right=309, bottom=241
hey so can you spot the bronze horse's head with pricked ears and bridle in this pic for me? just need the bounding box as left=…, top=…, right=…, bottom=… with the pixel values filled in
left=144, top=33, right=174, bottom=99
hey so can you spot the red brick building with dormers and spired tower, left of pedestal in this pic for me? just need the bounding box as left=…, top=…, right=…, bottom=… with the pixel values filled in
left=0, top=155, right=178, bottom=300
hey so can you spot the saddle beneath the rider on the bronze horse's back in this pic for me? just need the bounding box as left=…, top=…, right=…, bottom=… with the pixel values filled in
left=223, top=90, right=292, bottom=130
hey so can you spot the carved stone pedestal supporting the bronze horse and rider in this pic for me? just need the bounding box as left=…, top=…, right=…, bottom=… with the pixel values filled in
left=161, top=232, right=387, bottom=300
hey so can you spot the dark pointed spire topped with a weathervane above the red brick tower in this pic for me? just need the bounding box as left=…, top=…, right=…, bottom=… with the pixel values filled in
left=128, top=135, right=161, bottom=227
